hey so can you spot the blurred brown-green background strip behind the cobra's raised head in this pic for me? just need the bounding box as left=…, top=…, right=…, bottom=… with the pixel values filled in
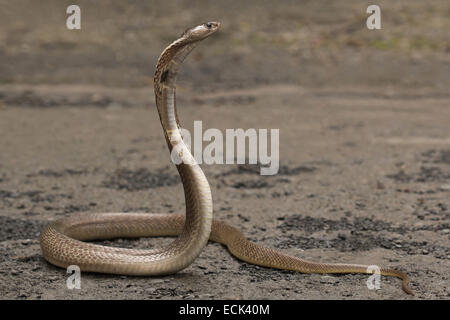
left=0, top=0, right=450, bottom=91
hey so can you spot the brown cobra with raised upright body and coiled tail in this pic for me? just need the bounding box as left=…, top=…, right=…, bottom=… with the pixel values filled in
left=40, top=22, right=413, bottom=294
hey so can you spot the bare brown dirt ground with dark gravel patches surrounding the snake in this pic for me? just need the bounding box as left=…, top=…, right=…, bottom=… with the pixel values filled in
left=0, top=0, right=450, bottom=299
